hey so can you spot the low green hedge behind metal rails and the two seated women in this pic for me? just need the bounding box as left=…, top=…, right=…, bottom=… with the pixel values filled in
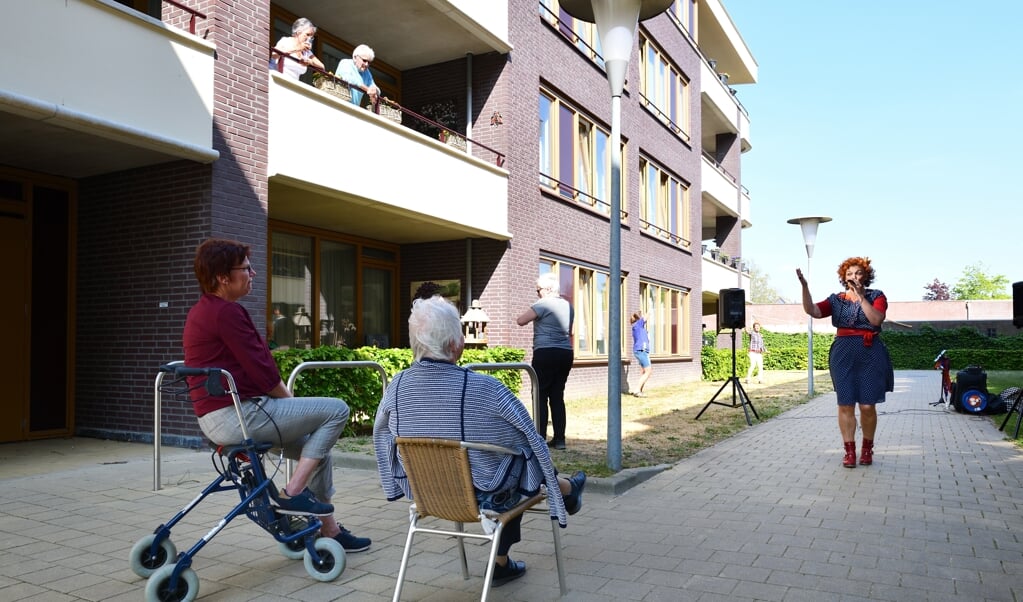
left=271, top=346, right=526, bottom=436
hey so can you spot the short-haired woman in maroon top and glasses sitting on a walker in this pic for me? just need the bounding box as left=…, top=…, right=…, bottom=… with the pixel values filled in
left=183, top=239, right=370, bottom=552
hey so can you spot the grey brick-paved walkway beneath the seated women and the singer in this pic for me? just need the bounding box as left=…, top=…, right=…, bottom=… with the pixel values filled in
left=0, top=371, right=1023, bottom=602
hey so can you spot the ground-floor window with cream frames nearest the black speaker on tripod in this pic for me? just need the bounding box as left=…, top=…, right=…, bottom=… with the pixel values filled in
left=639, top=281, right=692, bottom=355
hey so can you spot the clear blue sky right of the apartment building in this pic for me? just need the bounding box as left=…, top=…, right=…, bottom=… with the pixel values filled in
left=722, top=0, right=1023, bottom=301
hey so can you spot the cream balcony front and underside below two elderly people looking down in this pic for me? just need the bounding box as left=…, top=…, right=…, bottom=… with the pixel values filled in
left=267, top=72, right=512, bottom=244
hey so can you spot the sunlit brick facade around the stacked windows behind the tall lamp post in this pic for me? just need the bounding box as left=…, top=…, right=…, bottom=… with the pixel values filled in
left=497, top=8, right=701, bottom=394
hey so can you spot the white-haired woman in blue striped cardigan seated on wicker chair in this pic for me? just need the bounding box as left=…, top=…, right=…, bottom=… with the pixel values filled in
left=373, top=296, right=586, bottom=587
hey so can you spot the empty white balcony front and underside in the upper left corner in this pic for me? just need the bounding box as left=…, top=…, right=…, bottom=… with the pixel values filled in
left=0, top=0, right=218, bottom=177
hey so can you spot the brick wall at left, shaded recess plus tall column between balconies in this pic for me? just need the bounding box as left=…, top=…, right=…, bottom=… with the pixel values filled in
left=76, top=0, right=270, bottom=444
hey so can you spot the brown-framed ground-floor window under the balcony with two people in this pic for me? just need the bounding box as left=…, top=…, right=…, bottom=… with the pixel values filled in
left=268, top=223, right=398, bottom=347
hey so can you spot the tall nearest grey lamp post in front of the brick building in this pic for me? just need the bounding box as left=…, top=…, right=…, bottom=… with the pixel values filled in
left=560, top=0, right=672, bottom=471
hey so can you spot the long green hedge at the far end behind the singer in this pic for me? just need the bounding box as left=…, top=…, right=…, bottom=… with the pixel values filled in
left=702, top=326, right=1023, bottom=381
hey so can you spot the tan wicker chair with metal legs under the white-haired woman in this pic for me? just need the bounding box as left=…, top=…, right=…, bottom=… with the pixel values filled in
left=393, top=437, right=568, bottom=602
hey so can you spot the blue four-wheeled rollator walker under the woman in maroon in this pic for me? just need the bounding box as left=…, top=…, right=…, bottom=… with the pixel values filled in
left=129, top=362, right=346, bottom=602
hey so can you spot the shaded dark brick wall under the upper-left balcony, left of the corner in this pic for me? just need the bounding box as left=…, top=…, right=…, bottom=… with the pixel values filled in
left=75, top=161, right=211, bottom=439
